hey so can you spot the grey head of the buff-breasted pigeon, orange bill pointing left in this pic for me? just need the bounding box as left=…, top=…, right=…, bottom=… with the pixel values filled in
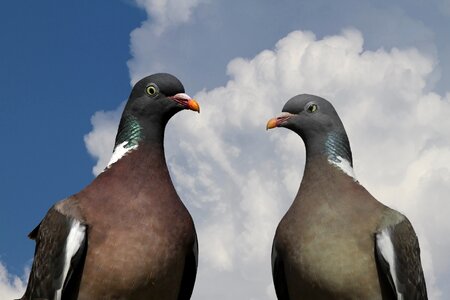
left=266, top=94, right=352, bottom=164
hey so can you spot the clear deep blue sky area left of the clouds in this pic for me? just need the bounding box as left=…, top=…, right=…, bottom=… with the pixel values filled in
left=0, top=1, right=145, bottom=272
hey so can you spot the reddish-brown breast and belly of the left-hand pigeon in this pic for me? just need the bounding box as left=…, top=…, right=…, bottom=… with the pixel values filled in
left=75, top=143, right=196, bottom=299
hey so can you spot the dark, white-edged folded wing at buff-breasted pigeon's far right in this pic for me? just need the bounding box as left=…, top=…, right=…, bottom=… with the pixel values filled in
left=375, top=218, right=427, bottom=300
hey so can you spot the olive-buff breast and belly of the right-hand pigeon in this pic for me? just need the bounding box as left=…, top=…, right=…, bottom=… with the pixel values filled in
left=274, top=158, right=400, bottom=299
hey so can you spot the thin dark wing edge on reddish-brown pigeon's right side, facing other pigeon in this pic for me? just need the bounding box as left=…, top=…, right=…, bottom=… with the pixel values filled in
left=178, top=233, right=198, bottom=300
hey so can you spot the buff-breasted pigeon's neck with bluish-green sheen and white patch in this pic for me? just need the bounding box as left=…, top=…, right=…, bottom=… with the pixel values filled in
left=305, top=132, right=356, bottom=181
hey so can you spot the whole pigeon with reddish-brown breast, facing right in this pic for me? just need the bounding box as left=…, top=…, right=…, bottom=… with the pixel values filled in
left=21, top=73, right=200, bottom=300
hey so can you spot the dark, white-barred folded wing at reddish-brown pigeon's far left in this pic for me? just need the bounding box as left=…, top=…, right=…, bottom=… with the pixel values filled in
left=22, top=206, right=87, bottom=300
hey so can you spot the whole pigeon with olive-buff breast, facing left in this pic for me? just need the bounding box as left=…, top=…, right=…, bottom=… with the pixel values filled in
left=266, top=94, right=427, bottom=300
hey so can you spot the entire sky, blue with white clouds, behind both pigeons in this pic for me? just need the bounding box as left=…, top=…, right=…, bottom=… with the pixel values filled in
left=0, top=0, right=450, bottom=299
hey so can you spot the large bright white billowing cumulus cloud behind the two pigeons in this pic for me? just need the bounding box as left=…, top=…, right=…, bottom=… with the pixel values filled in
left=86, top=29, right=450, bottom=299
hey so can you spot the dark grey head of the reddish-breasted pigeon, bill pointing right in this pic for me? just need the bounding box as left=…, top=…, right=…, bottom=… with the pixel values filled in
left=115, top=73, right=200, bottom=147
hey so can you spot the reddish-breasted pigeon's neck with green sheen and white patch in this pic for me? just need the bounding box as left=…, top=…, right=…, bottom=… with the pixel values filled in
left=107, top=115, right=166, bottom=168
